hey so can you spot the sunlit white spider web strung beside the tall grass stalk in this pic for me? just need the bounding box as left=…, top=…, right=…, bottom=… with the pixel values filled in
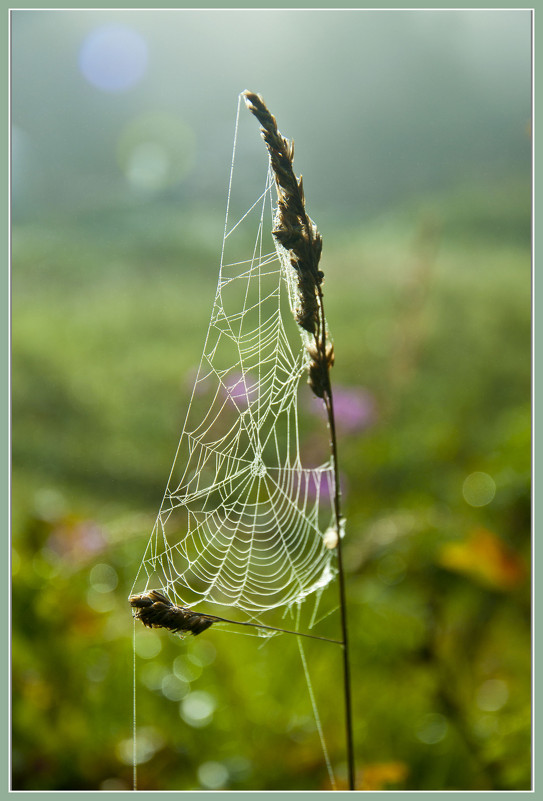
left=134, top=104, right=334, bottom=620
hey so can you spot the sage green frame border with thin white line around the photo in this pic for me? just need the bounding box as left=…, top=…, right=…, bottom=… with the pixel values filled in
left=7, top=0, right=541, bottom=801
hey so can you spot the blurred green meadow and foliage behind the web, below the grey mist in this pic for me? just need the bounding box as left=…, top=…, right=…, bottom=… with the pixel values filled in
left=12, top=175, right=531, bottom=790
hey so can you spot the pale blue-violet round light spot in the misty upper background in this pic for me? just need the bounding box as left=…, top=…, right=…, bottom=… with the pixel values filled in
left=79, top=24, right=148, bottom=92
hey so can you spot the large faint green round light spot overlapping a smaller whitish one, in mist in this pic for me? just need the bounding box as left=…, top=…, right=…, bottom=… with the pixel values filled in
left=117, top=113, right=195, bottom=193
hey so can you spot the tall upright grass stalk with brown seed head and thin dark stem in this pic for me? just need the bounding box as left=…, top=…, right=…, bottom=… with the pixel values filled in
left=243, top=91, right=355, bottom=790
